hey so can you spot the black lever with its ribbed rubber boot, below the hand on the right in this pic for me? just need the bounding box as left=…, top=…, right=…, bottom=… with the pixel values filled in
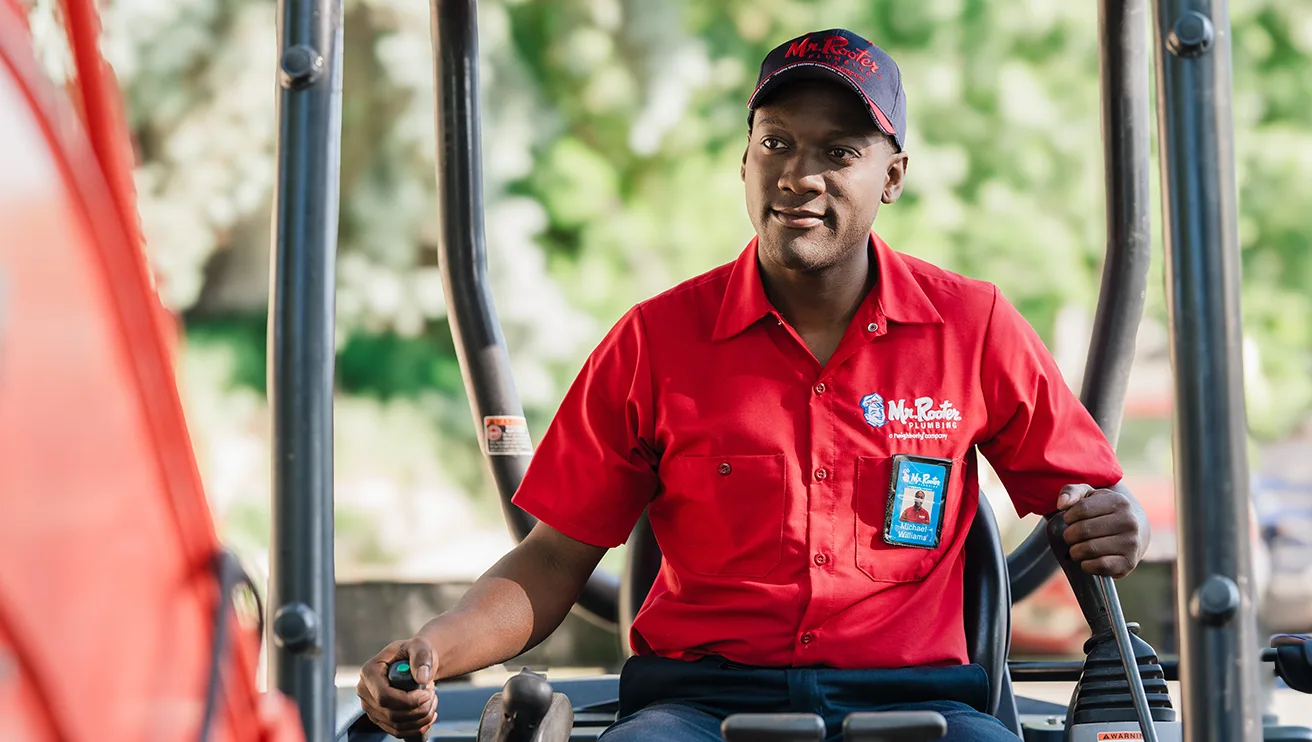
left=1047, top=513, right=1179, bottom=742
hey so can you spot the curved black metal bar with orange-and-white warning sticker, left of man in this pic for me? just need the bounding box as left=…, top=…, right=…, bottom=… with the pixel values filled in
left=432, top=0, right=619, bottom=628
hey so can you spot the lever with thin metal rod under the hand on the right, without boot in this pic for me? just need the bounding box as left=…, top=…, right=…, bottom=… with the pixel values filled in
left=1047, top=513, right=1157, bottom=742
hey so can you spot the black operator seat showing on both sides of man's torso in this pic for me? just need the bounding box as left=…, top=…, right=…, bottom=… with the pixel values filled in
left=619, top=493, right=1021, bottom=737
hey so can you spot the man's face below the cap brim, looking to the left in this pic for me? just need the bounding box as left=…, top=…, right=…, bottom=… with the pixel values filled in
left=743, top=81, right=907, bottom=271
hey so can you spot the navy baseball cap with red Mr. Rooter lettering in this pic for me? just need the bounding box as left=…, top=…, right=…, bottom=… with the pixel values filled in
left=747, top=29, right=907, bottom=151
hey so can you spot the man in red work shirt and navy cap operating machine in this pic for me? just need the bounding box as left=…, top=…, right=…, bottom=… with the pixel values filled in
left=358, top=30, right=1147, bottom=742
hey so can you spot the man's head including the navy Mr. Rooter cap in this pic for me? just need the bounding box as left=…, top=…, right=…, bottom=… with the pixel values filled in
left=743, top=29, right=907, bottom=271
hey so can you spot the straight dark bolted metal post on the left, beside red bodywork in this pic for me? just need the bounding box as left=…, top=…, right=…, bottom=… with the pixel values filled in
left=269, top=0, right=342, bottom=741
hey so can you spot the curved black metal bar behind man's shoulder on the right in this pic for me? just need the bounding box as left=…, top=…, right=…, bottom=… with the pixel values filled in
left=1008, top=0, right=1152, bottom=600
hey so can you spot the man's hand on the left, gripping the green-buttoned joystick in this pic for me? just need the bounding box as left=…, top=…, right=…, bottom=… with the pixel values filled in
left=356, top=637, right=437, bottom=741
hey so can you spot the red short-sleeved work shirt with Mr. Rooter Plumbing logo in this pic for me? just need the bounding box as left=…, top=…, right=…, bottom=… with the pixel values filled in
left=514, top=236, right=1122, bottom=669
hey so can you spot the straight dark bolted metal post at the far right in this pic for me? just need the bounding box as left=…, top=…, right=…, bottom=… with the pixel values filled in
left=1155, top=0, right=1262, bottom=742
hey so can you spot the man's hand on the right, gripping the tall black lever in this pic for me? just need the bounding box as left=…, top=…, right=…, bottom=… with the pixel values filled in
left=1057, top=484, right=1148, bottom=577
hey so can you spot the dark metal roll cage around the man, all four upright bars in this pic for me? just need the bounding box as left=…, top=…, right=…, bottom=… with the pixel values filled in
left=269, top=0, right=1261, bottom=742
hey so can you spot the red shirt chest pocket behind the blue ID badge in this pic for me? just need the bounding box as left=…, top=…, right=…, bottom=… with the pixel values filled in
left=853, top=456, right=966, bottom=582
